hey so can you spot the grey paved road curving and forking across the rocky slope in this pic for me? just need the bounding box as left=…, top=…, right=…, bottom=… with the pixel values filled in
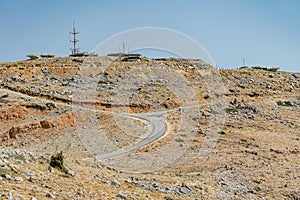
left=0, top=89, right=169, bottom=161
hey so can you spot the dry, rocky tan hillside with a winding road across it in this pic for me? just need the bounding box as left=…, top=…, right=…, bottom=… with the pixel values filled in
left=0, top=56, right=300, bottom=200
